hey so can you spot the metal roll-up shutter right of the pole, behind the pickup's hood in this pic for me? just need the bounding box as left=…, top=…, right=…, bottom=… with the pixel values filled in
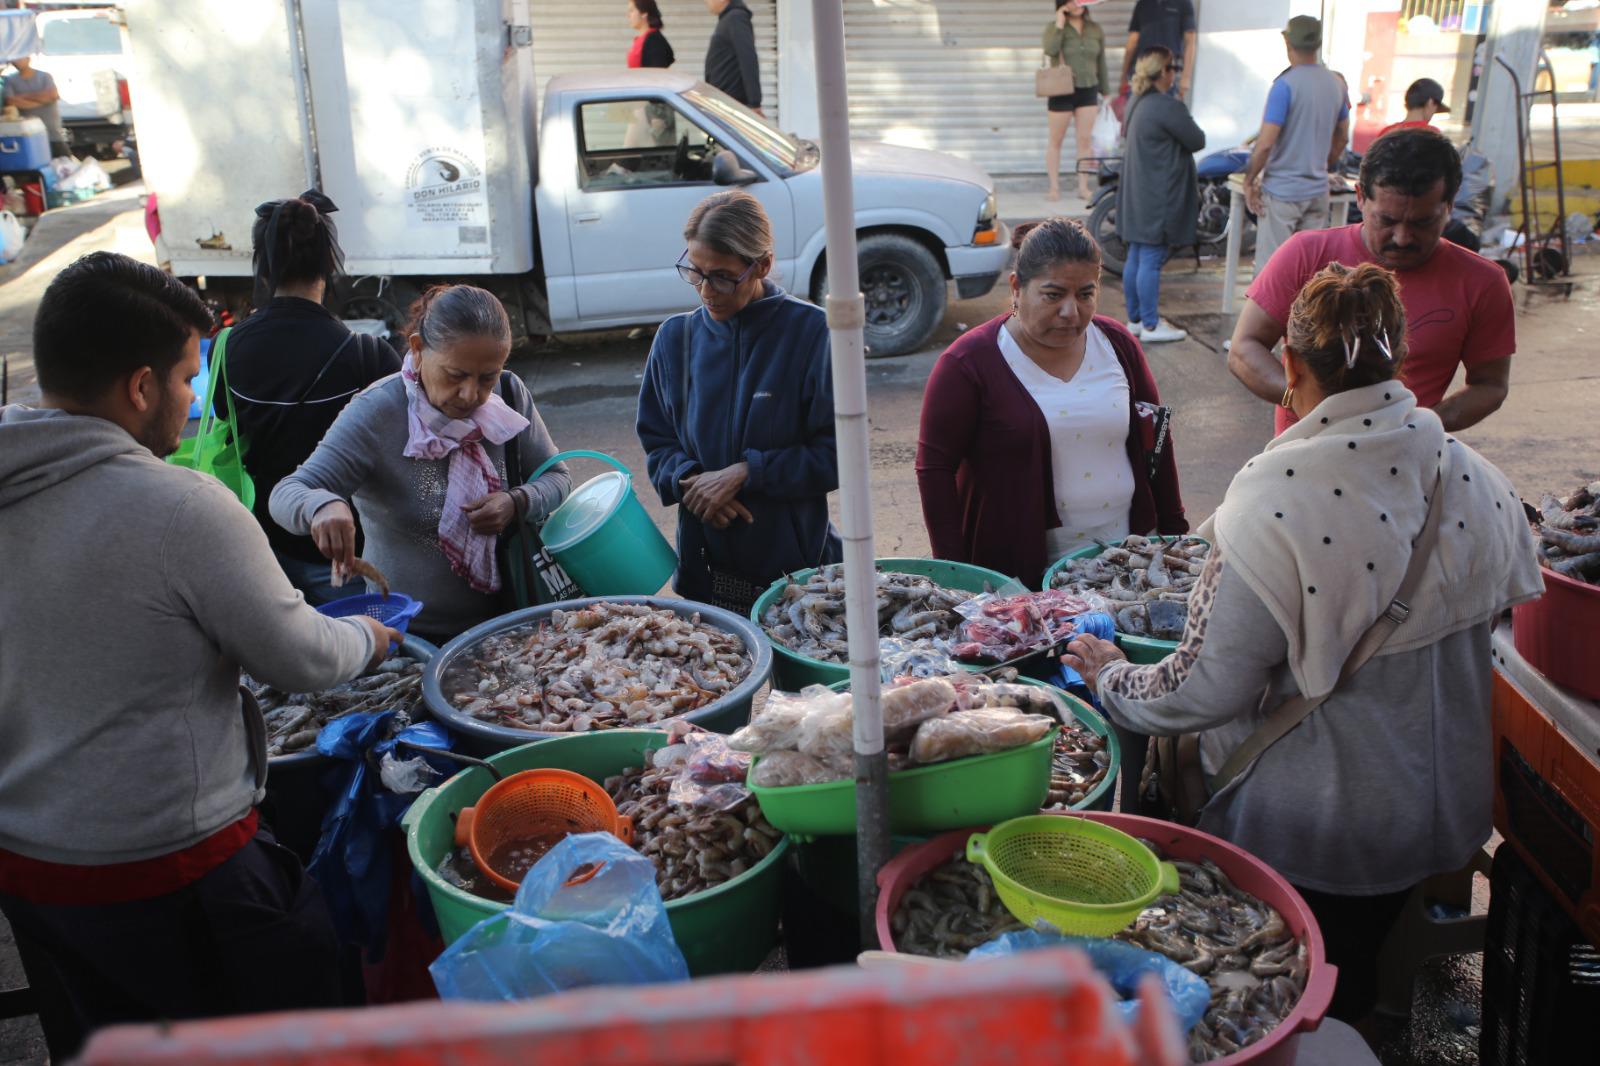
left=845, top=0, right=1133, bottom=174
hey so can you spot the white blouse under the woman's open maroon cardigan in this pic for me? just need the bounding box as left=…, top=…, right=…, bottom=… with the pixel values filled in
left=1000, top=325, right=1133, bottom=562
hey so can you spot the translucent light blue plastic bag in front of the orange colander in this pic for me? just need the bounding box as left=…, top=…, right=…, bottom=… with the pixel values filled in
left=429, top=832, right=690, bottom=1000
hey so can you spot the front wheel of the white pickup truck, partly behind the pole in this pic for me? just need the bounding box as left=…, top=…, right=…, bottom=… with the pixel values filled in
left=811, top=234, right=947, bottom=359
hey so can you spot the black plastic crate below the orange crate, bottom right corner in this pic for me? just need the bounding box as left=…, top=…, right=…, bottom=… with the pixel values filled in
left=1478, top=847, right=1600, bottom=1066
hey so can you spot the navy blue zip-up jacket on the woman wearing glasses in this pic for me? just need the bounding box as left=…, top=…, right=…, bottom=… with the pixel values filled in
left=637, top=282, right=842, bottom=600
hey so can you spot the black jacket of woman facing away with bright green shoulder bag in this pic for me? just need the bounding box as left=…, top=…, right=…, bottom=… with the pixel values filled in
left=214, top=296, right=400, bottom=562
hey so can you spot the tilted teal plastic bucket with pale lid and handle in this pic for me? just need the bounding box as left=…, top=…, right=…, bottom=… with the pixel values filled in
left=528, top=450, right=678, bottom=595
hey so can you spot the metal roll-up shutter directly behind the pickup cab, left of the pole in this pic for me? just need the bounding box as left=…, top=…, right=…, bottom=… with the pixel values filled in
left=533, top=0, right=778, bottom=115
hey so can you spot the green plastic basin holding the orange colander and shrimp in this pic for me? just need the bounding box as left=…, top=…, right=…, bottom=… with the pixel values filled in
left=402, top=730, right=789, bottom=976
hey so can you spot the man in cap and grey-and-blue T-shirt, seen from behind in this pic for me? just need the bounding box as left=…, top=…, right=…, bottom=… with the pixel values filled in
left=1245, top=14, right=1350, bottom=271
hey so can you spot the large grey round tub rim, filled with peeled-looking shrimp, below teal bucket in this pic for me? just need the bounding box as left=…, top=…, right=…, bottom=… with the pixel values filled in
left=422, top=595, right=773, bottom=757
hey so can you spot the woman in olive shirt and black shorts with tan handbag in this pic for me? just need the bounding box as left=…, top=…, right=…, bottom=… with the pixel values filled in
left=1034, top=0, right=1107, bottom=202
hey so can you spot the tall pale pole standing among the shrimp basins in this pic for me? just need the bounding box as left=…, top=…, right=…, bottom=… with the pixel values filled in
left=811, top=0, right=890, bottom=948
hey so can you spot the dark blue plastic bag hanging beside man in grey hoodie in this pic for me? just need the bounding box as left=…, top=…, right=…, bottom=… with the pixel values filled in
left=306, top=711, right=456, bottom=962
